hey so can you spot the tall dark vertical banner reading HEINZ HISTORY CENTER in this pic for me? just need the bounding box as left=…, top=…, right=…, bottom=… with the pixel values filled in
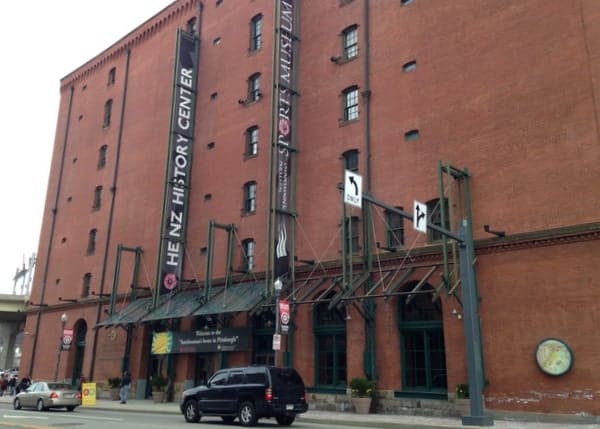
left=157, top=30, right=199, bottom=295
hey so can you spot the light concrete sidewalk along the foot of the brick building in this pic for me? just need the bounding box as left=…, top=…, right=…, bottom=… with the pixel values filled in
left=0, top=396, right=599, bottom=429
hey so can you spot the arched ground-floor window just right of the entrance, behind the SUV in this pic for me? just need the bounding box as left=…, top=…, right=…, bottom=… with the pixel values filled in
left=313, top=291, right=347, bottom=388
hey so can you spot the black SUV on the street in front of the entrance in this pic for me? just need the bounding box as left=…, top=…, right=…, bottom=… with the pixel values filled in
left=180, top=366, right=308, bottom=426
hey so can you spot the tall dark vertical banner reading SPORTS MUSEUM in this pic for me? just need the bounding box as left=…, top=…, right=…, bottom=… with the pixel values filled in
left=274, top=0, right=296, bottom=279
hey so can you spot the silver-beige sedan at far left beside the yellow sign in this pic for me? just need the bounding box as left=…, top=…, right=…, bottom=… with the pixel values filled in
left=13, top=381, right=81, bottom=411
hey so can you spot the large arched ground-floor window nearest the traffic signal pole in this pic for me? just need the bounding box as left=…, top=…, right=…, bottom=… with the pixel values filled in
left=397, top=282, right=448, bottom=393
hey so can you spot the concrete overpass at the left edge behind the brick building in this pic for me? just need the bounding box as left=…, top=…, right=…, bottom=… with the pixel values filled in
left=0, top=294, right=29, bottom=369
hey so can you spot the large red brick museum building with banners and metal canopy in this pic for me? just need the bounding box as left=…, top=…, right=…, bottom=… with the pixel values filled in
left=21, top=0, right=600, bottom=415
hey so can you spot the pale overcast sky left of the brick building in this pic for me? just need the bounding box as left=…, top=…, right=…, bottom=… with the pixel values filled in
left=0, top=0, right=174, bottom=293
